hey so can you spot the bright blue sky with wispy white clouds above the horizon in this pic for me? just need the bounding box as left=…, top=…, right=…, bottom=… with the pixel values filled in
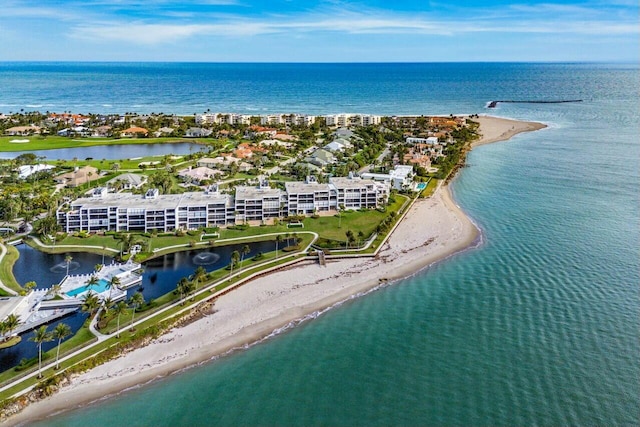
left=0, top=0, right=640, bottom=63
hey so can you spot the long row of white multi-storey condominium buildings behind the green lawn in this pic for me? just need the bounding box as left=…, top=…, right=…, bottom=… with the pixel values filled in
left=56, top=176, right=389, bottom=233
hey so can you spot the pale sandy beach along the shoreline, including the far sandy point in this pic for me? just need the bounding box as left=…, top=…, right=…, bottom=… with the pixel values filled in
left=8, top=116, right=546, bottom=424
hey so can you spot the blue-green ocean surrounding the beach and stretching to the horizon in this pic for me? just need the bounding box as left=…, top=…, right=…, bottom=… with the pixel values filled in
left=0, top=63, right=640, bottom=426
